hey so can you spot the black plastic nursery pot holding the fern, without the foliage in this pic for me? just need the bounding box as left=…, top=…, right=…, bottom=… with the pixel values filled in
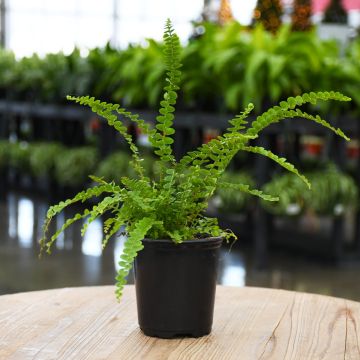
left=134, top=237, right=223, bottom=338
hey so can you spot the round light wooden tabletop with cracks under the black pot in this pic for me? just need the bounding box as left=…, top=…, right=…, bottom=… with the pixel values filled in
left=0, top=286, right=360, bottom=360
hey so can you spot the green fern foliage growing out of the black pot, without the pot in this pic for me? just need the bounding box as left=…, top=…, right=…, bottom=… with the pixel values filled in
left=40, top=20, right=350, bottom=298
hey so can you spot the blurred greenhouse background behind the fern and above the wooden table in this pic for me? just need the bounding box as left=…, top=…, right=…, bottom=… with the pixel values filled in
left=0, top=0, right=360, bottom=301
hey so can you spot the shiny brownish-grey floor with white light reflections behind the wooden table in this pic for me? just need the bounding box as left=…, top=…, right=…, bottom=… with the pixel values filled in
left=0, top=192, right=360, bottom=301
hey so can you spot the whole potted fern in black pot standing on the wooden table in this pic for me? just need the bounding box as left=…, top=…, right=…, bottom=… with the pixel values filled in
left=40, top=20, right=350, bottom=338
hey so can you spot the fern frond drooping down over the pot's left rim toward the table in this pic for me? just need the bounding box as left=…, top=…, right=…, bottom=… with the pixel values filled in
left=116, top=218, right=154, bottom=300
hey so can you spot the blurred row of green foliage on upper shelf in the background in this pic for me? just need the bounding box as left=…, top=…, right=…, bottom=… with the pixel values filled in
left=0, top=22, right=360, bottom=114
